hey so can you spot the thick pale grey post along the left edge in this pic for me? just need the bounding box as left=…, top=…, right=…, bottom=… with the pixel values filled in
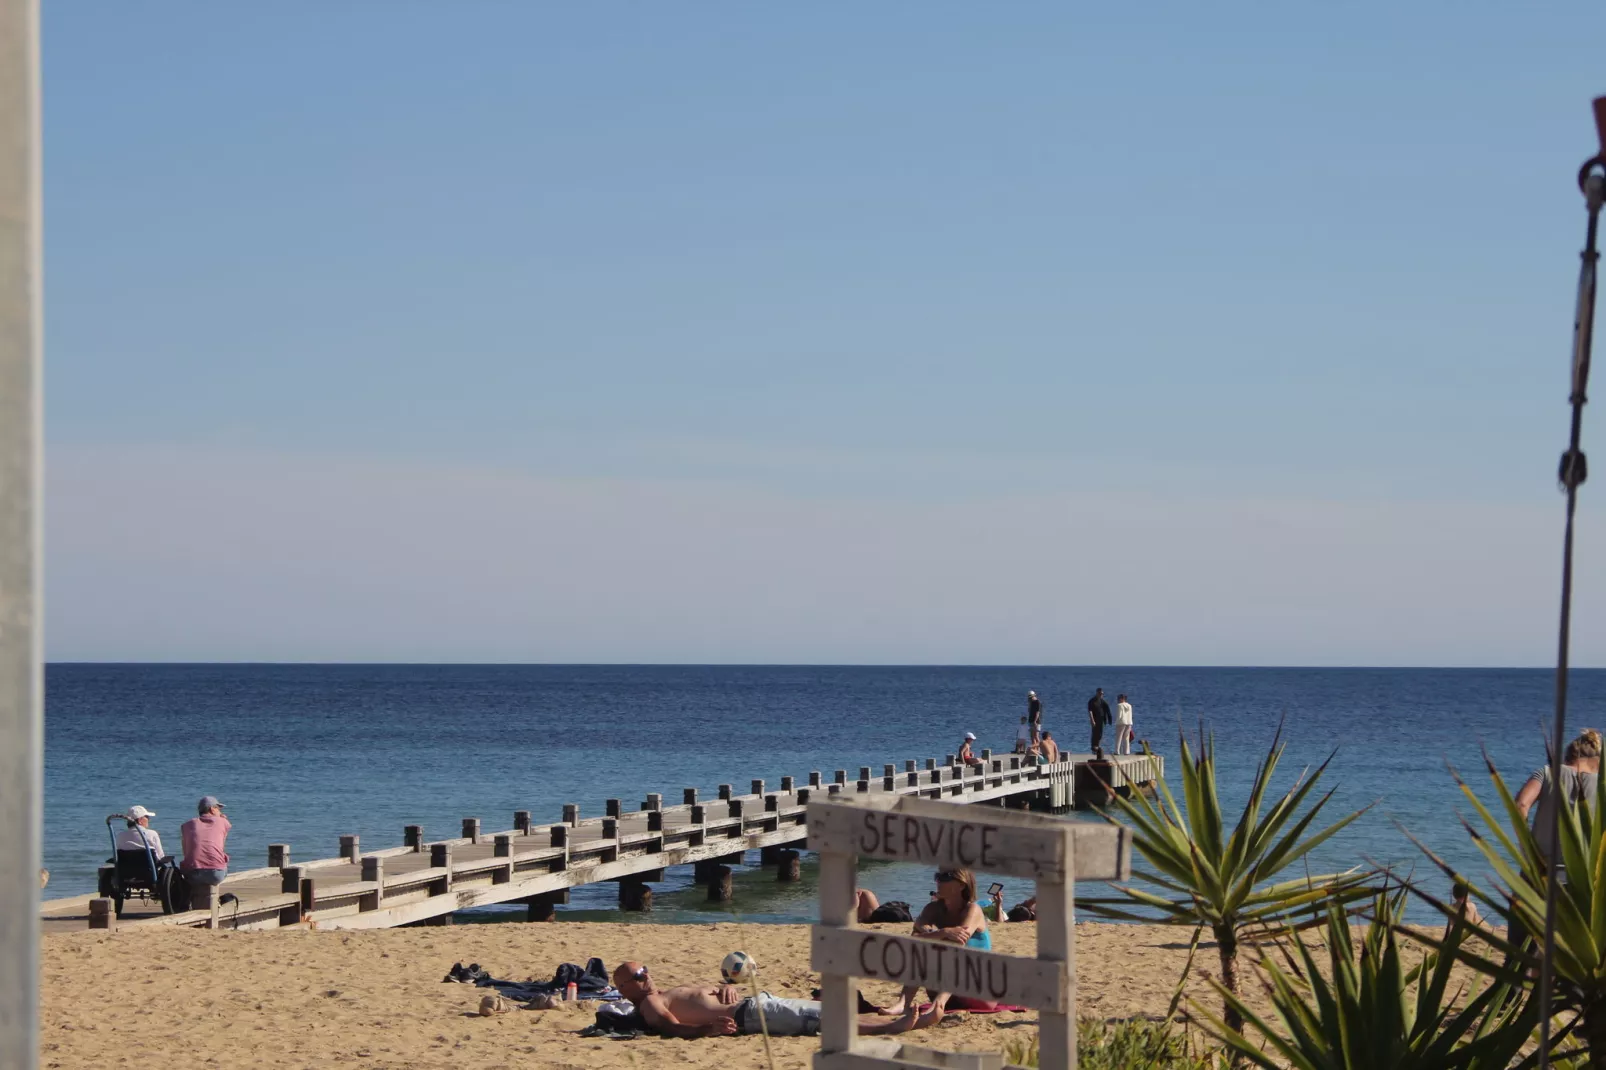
left=0, top=0, right=43, bottom=1070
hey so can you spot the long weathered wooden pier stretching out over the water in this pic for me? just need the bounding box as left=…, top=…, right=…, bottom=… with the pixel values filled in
left=42, top=750, right=1164, bottom=932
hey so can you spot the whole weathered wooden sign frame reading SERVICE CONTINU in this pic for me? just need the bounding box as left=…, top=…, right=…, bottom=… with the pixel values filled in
left=808, top=795, right=1131, bottom=1070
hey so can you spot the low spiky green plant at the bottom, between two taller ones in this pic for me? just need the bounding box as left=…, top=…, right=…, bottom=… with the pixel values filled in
left=1195, top=892, right=1539, bottom=1070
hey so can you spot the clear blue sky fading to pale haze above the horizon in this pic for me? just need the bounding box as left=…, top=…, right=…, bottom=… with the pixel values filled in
left=43, top=2, right=1606, bottom=665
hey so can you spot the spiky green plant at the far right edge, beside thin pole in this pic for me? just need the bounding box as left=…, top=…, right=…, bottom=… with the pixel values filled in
left=1412, top=755, right=1606, bottom=1068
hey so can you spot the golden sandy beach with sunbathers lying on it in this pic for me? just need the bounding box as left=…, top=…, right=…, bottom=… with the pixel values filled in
left=40, top=922, right=1214, bottom=1070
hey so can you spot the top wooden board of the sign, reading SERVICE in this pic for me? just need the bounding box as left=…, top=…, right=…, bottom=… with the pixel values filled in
left=808, top=795, right=1131, bottom=882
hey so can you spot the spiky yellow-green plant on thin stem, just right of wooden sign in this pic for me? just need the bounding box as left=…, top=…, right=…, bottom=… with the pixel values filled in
left=1078, top=726, right=1373, bottom=1028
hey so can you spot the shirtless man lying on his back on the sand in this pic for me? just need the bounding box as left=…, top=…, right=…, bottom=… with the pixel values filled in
left=613, top=962, right=898, bottom=1039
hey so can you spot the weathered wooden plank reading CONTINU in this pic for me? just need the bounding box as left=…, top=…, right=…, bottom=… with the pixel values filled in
left=813, top=925, right=1070, bottom=1014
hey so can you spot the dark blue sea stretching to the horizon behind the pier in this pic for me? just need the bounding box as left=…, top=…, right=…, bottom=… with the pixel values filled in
left=45, top=664, right=1606, bottom=921
